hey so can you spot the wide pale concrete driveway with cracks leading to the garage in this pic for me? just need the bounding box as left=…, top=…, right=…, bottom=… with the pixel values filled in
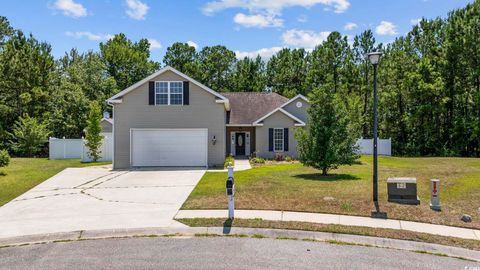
left=0, top=167, right=205, bottom=237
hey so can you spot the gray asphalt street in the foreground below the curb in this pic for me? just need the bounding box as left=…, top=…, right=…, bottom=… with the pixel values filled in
left=0, top=237, right=480, bottom=270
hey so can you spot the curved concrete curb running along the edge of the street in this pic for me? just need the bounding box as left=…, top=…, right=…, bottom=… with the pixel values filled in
left=0, top=227, right=480, bottom=262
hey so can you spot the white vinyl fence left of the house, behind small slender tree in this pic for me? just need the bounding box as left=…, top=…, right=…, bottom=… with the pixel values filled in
left=48, top=133, right=113, bottom=162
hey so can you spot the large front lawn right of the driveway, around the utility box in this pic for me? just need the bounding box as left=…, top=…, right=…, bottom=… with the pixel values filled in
left=182, top=156, right=480, bottom=229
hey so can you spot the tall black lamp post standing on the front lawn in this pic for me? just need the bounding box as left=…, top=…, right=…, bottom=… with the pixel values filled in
left=368, top=52, right=387, bottom=218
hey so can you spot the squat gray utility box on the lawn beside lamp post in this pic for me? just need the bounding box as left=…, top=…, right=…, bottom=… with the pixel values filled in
left=387, top=177, right=420, bottom=204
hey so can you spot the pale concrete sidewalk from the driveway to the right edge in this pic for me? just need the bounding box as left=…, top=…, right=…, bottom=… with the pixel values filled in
left=175, top=210, right=480, bottom=240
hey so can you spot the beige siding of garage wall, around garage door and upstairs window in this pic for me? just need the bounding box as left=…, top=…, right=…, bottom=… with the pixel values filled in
left=114, top=71, right=226, bottom=169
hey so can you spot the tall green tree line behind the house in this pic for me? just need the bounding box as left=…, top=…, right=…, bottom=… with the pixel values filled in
left=0, top=0, right=480, bottom=157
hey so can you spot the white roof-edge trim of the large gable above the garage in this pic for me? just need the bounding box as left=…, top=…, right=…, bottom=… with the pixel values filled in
left=107, top=66, right=229, bottom=110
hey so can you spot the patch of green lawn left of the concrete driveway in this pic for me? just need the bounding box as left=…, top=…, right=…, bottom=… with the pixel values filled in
left=0, top=158, right=110, bottom=206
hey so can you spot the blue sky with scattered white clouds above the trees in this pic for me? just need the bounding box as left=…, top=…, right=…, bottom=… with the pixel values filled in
left=0, top=0, right=473, bottom=61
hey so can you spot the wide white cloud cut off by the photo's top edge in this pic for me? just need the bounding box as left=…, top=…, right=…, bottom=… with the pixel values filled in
left=203, top=0, right=350, bottom=15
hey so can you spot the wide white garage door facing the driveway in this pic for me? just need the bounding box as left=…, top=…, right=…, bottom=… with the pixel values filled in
left=130, top=129, right=208, bottom=167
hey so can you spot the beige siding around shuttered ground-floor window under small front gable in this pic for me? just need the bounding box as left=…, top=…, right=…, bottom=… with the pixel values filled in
left=255, top=112, right=298, bottom=159
